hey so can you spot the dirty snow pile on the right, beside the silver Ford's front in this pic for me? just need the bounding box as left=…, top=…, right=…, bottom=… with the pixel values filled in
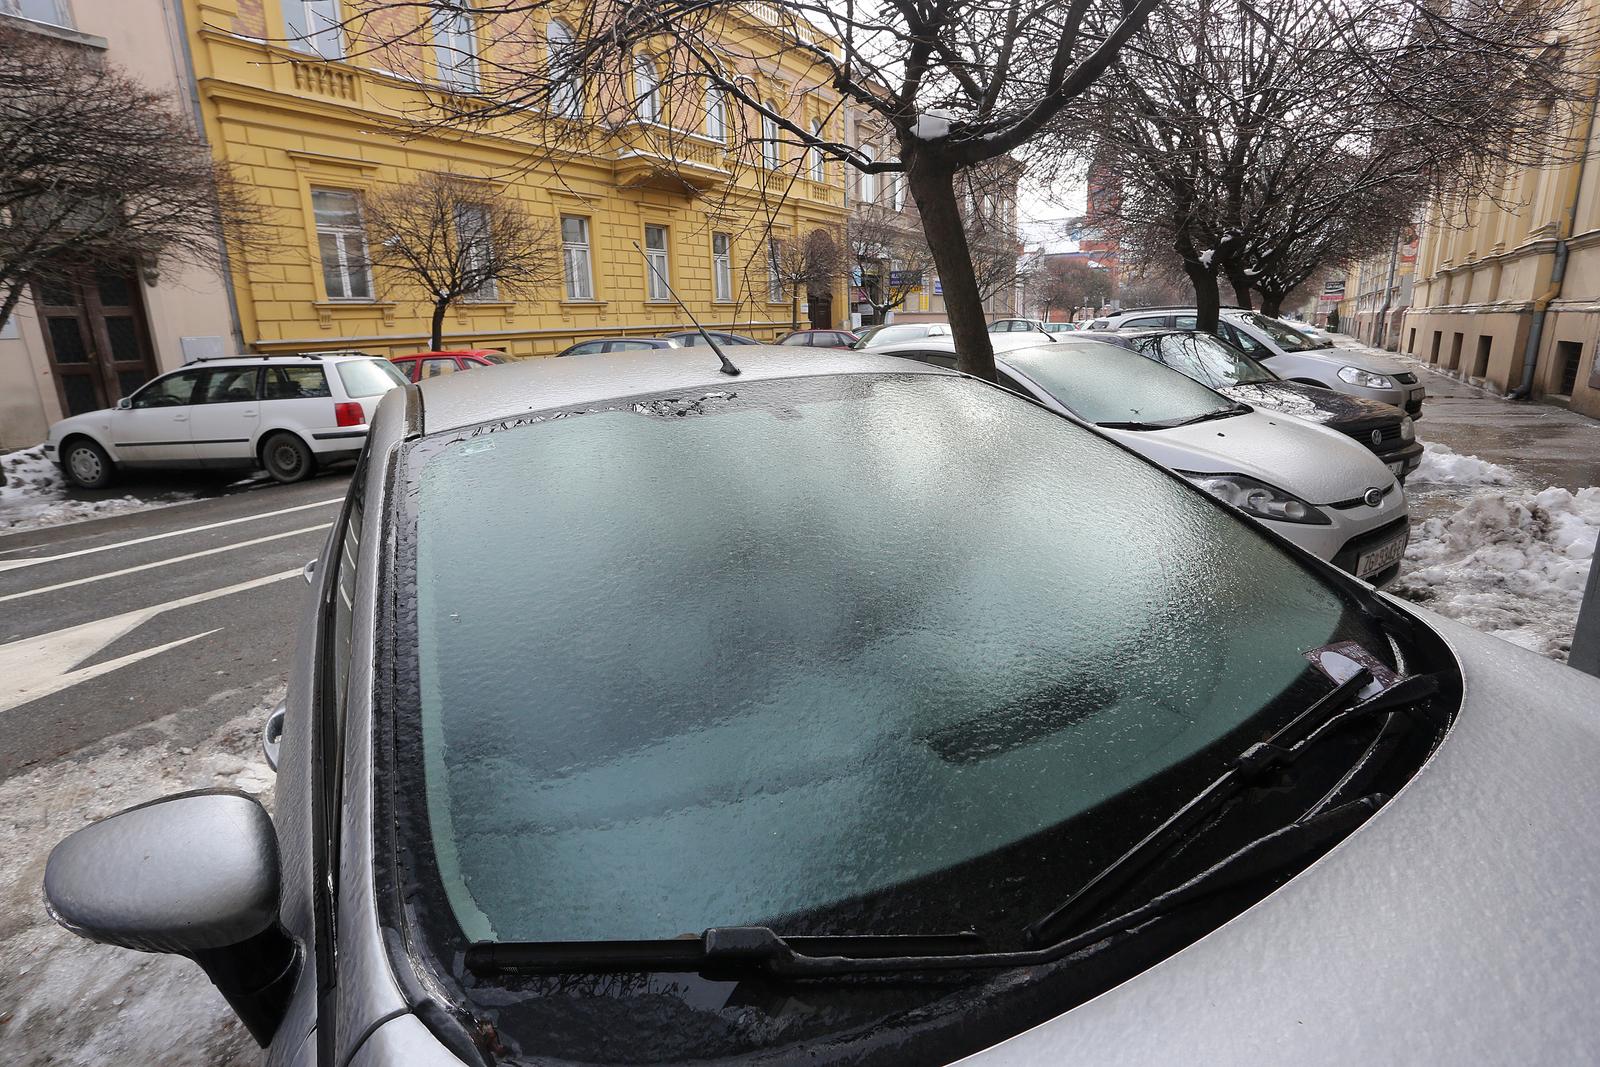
left=1389, top=486, right=1600, bottom=661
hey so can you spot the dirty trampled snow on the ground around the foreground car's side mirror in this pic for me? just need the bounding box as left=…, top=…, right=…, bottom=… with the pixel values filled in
left=0, top=689, right=282, bottom=1067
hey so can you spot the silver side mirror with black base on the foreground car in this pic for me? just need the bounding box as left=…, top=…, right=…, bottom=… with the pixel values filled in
left=45, top=789, right=299, bottom=1046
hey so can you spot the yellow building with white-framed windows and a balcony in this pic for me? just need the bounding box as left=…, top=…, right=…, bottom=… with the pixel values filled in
left=182, top=0, right=845, bottom=355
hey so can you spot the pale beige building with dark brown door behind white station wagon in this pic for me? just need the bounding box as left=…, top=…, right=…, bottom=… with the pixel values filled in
left=0, top=0, right=238, bottom=451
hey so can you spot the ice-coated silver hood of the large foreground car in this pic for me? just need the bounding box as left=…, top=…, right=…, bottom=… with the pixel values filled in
left=962, top=605, right=1600, bottom=1067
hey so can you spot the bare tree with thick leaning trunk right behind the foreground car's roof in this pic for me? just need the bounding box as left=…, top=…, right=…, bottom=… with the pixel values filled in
left=337, top=0, right=1162, bottom=379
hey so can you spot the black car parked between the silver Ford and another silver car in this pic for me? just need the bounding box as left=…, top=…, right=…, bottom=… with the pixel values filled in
left=1113, top=330, right=1422, bottom=485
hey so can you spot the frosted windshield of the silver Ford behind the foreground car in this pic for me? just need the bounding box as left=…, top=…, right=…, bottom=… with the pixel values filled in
left=1005, top=341, right=1235, bottom=429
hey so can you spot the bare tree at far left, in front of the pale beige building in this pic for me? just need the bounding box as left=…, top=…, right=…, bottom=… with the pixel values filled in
left=0, top=24, right=264, bottom=334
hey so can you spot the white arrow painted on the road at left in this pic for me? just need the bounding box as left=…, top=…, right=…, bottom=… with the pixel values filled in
left=0, top=569, right=299, bottom=713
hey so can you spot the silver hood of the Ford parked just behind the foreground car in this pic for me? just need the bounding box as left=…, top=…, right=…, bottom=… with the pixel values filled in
left=1104, top=411, right=1394, bottom=504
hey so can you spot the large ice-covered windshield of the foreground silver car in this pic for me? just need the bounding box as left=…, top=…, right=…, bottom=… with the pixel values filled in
left=398, top=375, right=1344, bottom=941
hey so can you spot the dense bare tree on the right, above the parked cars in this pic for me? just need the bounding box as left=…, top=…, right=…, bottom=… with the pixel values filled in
left=1070, top=0, right=1590, bottom=328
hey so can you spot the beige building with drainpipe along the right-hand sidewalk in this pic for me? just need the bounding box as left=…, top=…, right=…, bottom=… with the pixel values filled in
left=1400, top=86, right=1600, bottom=416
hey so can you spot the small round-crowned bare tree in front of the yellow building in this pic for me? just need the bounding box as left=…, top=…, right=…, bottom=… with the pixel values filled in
left=363, top=173, right=560, bottom=350
